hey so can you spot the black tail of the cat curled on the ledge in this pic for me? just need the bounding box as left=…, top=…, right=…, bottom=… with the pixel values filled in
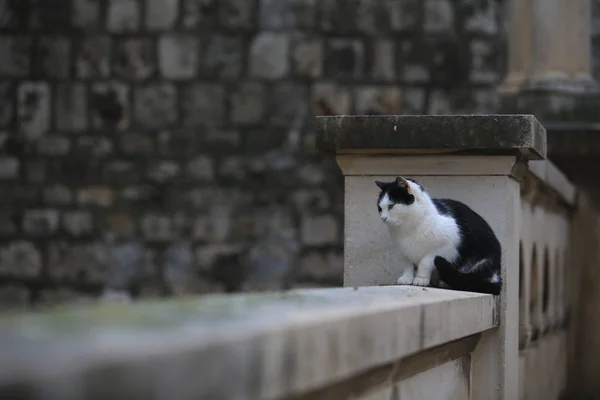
left=433, top=256, right=502, bottom=296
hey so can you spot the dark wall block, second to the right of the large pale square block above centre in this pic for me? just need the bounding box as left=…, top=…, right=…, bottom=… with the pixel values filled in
left=325, top=39, right=365, bottom=79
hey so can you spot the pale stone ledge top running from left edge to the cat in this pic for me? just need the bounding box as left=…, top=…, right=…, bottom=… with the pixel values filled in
left=0, top=286, right=497, bottom=400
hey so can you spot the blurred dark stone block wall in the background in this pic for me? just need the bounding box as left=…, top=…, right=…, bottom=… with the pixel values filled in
left=0, top=0, right=504, bottom=307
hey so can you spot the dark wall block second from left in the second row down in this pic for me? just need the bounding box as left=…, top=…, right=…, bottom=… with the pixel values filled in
left=34, top=36, right=71, bottom=79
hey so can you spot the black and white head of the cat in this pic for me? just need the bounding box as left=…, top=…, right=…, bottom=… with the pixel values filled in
left=375, top=176, right=423, bottom=226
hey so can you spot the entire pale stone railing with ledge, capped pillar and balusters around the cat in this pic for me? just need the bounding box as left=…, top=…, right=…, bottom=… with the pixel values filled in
left=0, top=115, right=575, bottom=400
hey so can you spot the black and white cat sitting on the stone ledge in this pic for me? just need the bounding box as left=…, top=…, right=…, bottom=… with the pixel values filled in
left=375, top=177, right=502, bottom=295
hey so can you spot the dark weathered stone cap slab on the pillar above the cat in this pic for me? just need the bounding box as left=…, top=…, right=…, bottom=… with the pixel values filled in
left=316, top=114, right=546, bottom=160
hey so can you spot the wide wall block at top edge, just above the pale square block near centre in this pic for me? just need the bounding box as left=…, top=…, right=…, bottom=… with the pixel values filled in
left=260, top=0, right=317, bottom=30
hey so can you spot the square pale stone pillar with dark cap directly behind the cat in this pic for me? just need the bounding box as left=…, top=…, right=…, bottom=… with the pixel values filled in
left=317, top=115, right=546, bottom=400
